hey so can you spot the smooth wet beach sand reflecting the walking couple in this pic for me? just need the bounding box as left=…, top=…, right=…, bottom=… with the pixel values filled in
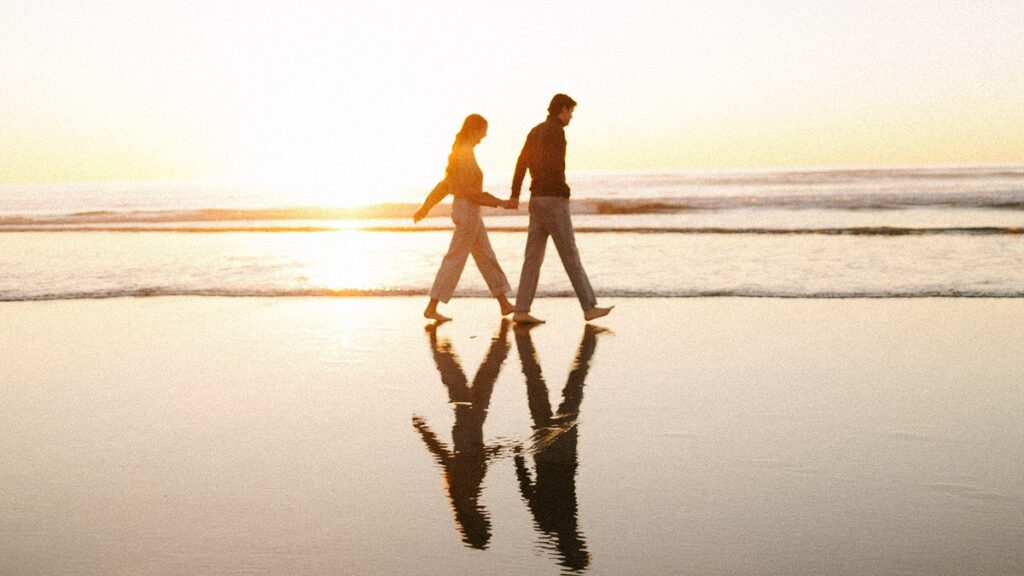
left=0, top=297, right=1024, bottom=576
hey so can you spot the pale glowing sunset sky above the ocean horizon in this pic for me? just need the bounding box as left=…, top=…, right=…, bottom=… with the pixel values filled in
left=0, top=0, right=1024, bottom=194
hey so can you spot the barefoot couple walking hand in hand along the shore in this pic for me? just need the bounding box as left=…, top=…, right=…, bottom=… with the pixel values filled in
left=413, top=94, right=611, bottom=324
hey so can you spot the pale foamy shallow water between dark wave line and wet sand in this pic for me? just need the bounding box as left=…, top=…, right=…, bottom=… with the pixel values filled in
left=0, top=217, right=1024, bottom=300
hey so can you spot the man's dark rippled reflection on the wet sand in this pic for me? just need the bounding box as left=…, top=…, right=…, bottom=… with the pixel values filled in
left=515, top=325, right=603, bottom=570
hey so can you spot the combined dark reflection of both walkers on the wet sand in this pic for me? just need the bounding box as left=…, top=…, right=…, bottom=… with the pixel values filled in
left=413, top=321, right=603, bottom=572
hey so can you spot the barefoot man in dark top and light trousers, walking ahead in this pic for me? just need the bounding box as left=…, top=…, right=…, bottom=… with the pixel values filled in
left=509, top=94, right=611, bottom=324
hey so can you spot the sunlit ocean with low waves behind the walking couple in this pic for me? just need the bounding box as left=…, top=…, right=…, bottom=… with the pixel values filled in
left=0, top=165, right=1024, bottom=303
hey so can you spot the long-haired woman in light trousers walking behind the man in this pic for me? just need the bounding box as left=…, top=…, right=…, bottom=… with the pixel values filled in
left=413, top=114, right=512, bottom=322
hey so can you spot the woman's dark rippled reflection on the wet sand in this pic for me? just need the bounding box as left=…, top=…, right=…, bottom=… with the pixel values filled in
left=413, top=320, right=509, bottom=549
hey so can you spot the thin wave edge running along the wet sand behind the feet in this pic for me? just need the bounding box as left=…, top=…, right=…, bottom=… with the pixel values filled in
left=0, top=287, right=1024, bottom=302
